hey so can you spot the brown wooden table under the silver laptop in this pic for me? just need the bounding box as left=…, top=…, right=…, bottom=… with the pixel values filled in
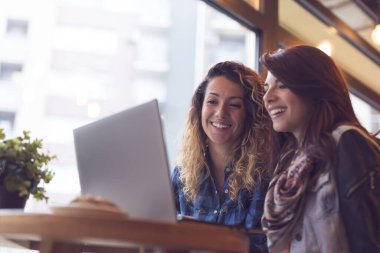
left=0, top=211, right=249, bottom=253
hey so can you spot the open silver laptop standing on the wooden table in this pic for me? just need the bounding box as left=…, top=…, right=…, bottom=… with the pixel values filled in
left=74, top=100, right=176, bottom=223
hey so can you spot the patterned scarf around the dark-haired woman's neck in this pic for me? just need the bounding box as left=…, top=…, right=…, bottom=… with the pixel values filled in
left=262, top=153, right=313, bottom=252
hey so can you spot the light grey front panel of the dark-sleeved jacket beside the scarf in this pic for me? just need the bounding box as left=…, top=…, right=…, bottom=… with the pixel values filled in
left=290, top=167, right=349, bottom=253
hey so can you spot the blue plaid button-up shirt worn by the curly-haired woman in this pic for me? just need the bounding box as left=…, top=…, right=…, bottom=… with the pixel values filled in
left=172, top=167, right=268, bottom=252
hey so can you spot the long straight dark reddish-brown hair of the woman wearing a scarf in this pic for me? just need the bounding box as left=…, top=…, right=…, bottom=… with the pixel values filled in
left=260, top=45, right=373, bottom=173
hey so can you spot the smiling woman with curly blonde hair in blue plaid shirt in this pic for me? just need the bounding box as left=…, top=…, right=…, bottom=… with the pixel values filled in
left=172, top=62, right=272, bottom=252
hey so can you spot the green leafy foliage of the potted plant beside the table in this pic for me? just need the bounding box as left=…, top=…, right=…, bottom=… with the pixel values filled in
left=0, top=128, right=56, bottom=202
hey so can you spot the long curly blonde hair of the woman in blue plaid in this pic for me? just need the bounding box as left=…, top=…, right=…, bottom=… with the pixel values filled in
left=178, top=61, right=273, bottom=201
